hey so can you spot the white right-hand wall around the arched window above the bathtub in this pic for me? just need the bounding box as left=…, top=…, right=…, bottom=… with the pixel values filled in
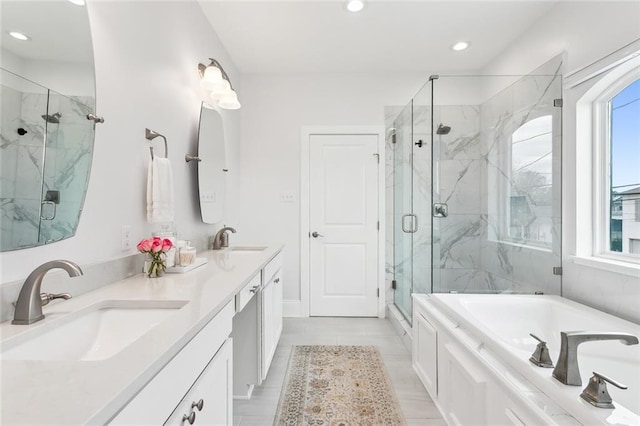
left=483, top=1, right=640, bottom=322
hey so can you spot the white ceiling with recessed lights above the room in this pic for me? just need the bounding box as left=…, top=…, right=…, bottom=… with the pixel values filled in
left=198, top=0, right=557, bottom=73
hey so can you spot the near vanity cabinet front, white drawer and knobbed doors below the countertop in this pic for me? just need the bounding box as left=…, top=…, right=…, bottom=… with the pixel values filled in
left=110, top=301, right=235, bottom=425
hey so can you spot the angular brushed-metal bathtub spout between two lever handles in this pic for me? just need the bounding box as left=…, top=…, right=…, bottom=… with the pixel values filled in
left=553, top=331, right=638, bottom=386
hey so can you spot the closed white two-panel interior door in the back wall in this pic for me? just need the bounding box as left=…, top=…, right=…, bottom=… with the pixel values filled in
left=309, top=134, right=379, bottom=317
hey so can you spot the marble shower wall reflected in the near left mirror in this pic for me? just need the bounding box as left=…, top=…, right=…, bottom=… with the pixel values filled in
left=0, top=81, right=94, bottom=250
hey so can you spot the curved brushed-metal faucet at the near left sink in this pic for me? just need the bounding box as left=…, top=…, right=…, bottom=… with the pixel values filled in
left=11, top=260, right=82, bottom=325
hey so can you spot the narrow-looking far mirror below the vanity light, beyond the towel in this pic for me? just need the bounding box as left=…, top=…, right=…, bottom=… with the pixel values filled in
left=198, top=103, right=227, bottom=223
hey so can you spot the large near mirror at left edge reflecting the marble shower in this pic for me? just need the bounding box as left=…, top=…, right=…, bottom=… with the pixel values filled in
left=0, top=0, right=95, bottom=251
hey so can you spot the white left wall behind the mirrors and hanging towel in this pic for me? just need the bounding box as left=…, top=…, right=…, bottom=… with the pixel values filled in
left=0, top=0, right=244, bottom=283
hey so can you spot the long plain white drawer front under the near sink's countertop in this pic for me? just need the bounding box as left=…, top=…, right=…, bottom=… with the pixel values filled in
left=110, top=302, right=234, bottom=425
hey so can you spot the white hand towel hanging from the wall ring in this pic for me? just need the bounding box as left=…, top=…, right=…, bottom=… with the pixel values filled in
left=147, top=157, right=173, bottom=223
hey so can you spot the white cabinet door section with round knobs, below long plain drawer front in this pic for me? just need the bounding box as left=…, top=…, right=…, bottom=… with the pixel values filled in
left=165, top=339, right=233, bottom=426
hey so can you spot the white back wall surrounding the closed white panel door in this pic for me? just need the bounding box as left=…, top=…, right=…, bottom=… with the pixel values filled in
left=238, top=73, right=428, bottom=303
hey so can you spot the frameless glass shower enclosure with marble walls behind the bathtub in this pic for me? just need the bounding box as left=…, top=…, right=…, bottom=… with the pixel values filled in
left=388, top=60, right=562, bottom=321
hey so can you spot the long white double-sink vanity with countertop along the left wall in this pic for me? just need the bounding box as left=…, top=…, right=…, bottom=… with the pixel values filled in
left=0, top=246, right=282, bottom=425
